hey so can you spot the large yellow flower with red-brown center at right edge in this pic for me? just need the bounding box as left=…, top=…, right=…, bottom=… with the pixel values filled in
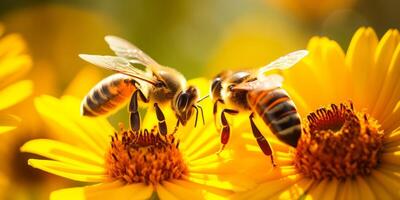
left=235, top=28, right=400, bottom=199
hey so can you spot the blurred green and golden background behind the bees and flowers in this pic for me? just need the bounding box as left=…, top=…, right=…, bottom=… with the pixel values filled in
left=0, top=0, right=400, bottom=199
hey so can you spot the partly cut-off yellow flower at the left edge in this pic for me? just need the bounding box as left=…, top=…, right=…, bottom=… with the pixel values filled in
left=0, top=25, right=32, bottom=134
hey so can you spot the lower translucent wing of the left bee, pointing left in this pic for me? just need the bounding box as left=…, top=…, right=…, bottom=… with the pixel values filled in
left=79, top=54, right=156, bottom=85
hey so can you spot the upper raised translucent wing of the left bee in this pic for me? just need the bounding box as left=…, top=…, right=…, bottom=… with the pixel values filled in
left=104, top=35, right=160, bottom=66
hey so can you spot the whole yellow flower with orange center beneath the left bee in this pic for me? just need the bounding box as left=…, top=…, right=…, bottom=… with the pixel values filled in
left=21, top=79, right=253, bottom=199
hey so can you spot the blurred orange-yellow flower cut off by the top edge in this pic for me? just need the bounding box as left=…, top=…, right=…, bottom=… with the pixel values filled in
left=266, top=0, right=357, bottom=21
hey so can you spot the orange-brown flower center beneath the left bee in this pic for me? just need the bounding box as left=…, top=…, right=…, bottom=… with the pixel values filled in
left=106, top=124, right=188, bottom=185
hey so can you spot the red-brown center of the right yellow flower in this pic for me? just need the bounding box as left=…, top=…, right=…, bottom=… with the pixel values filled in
left=294, top=103, right=383, bottom=180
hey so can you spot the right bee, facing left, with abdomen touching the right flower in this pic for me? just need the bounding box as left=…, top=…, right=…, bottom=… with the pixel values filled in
left=211, top=50, right=308, bottom=166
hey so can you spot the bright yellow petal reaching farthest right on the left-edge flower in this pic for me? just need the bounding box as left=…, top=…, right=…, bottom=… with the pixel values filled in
left=0, top=80, right=33, bottom=110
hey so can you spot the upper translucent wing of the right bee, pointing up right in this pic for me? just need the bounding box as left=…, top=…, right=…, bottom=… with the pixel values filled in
left=258, top=50, right=308, bottom=78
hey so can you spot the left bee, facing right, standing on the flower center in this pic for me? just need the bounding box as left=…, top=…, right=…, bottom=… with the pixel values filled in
left=79, top=36, right=207, bottom=136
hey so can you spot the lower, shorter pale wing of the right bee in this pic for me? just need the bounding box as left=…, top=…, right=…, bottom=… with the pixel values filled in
left=233, top=74, right=283, bottom=91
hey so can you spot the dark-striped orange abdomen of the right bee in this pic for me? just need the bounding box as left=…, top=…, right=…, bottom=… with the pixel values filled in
left=248, top=88, right=301, bottom=147
